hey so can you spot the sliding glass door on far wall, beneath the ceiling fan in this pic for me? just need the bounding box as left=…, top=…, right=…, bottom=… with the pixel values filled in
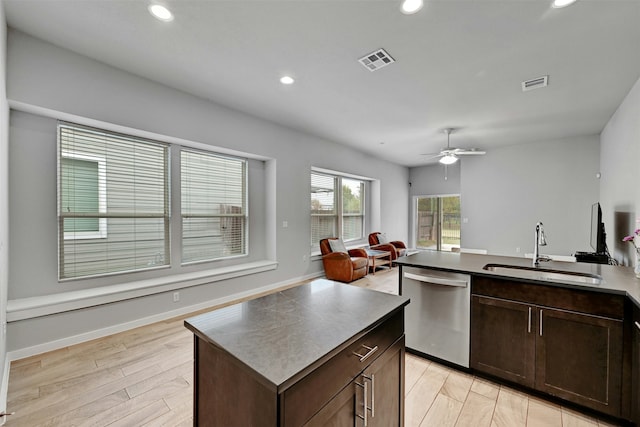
left=415, top=196, right=460, bottom=251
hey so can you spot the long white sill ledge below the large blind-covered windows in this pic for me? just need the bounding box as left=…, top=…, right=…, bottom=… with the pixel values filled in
left=7, top=260, right=278, bottom=322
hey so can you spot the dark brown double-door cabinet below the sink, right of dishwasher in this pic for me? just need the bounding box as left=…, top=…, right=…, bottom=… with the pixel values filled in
left=470, top=277, right=624, bottom=417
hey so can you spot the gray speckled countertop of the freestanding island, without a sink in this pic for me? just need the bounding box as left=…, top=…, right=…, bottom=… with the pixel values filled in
left=185, top=279, right=409, bottom=392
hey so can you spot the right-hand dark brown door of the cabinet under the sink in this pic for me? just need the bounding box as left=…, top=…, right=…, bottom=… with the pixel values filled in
left=536, top=308, right=622, bottom=416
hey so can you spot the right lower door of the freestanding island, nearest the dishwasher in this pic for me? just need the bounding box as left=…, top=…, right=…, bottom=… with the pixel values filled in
left=364, top=337, right=405, bottom=427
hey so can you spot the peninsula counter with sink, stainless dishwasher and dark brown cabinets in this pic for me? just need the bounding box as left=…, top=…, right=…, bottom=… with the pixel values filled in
left=396, top=251, right=640, bottom=423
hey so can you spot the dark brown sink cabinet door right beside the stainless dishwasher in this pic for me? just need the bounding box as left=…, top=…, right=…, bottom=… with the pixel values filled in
left=471, top=295, right=536, bottom=387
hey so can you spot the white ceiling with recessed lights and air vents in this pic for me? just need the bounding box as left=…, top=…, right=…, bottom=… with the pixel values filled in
left=4, top=0, right=640, bottom=166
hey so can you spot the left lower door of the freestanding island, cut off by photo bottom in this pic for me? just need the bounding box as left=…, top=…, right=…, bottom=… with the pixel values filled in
left=304, top=381, right=364, bottom=427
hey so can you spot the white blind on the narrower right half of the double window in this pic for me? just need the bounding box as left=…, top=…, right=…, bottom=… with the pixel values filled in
left=180, top=149, right=248, bottom=264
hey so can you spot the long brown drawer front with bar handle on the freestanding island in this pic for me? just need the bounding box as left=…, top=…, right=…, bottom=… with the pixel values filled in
left=280, top=310, right=404, bottom=426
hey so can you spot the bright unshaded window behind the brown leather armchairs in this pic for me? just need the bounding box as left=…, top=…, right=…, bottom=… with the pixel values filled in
left=311, top=172, right=365, bottom=248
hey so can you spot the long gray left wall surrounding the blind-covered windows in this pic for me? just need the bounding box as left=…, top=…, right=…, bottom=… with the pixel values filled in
left=7, top=30, right=408, bottom=350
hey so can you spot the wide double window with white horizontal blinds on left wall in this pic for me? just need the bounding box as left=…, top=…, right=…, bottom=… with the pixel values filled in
left=58, top=122, right=248, bottom=280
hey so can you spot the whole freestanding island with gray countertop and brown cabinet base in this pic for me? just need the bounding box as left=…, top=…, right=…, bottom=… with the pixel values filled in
left=185, top=280, right=408, bottom=427
